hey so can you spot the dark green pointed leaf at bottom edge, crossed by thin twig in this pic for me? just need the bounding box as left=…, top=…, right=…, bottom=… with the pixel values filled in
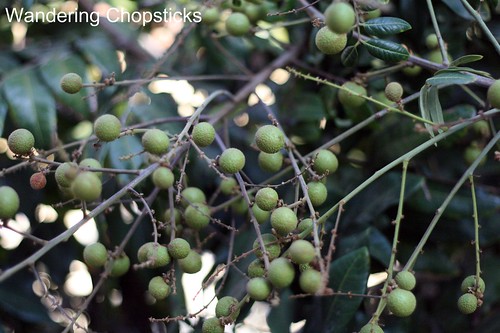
left=325, top=247, right=370, bottom=332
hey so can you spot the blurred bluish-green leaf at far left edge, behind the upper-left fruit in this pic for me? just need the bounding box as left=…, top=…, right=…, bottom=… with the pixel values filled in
left=2, top=68, right=56, bottom=148
